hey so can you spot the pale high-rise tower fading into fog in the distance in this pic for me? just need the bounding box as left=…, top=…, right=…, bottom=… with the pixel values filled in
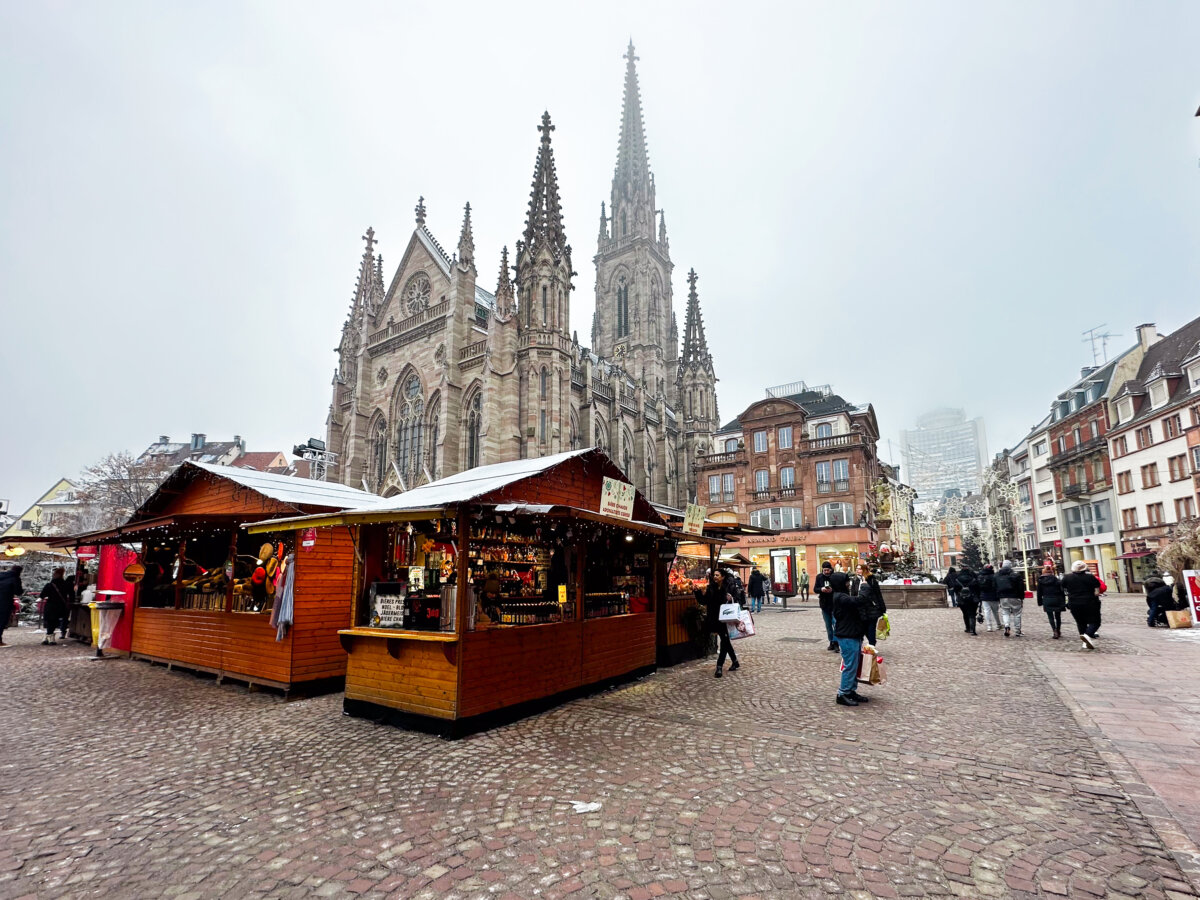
left=900, top=408, right=988, bottom=502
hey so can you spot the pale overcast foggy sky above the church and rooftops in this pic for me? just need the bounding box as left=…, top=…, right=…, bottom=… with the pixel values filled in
left=0, top=2, right=1200, bottom=509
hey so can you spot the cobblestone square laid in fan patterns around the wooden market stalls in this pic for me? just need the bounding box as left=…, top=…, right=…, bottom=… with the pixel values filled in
left=0, top=599, right=1195, bottom=900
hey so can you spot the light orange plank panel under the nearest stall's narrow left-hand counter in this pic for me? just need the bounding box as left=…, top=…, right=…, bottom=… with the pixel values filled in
left=346, top=637, right=458, bottom=719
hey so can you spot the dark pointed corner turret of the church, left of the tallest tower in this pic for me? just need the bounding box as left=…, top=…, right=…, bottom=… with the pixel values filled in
left=515, top=113, right=574, bottom=457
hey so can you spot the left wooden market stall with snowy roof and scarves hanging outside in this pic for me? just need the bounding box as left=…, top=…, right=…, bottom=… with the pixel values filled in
left=52, top=462, right=379, bottom=691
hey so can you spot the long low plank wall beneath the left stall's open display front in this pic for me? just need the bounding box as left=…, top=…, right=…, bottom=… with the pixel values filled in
left=131, top=606, right=292, bottom=684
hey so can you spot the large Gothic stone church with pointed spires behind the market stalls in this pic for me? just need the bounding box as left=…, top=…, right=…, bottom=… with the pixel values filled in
left=326, top=44, right=719, bottom=506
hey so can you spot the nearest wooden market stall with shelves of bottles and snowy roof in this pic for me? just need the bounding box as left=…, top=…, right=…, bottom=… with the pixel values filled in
left=248, top=450, right=696, bottom=736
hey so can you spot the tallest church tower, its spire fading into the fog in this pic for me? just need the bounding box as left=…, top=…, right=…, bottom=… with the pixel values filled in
left=592, top=41, right=676, bottom=404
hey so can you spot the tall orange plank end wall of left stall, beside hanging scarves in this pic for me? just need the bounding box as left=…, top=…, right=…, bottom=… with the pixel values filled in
left=292, top=528, right=355, bottom=682
